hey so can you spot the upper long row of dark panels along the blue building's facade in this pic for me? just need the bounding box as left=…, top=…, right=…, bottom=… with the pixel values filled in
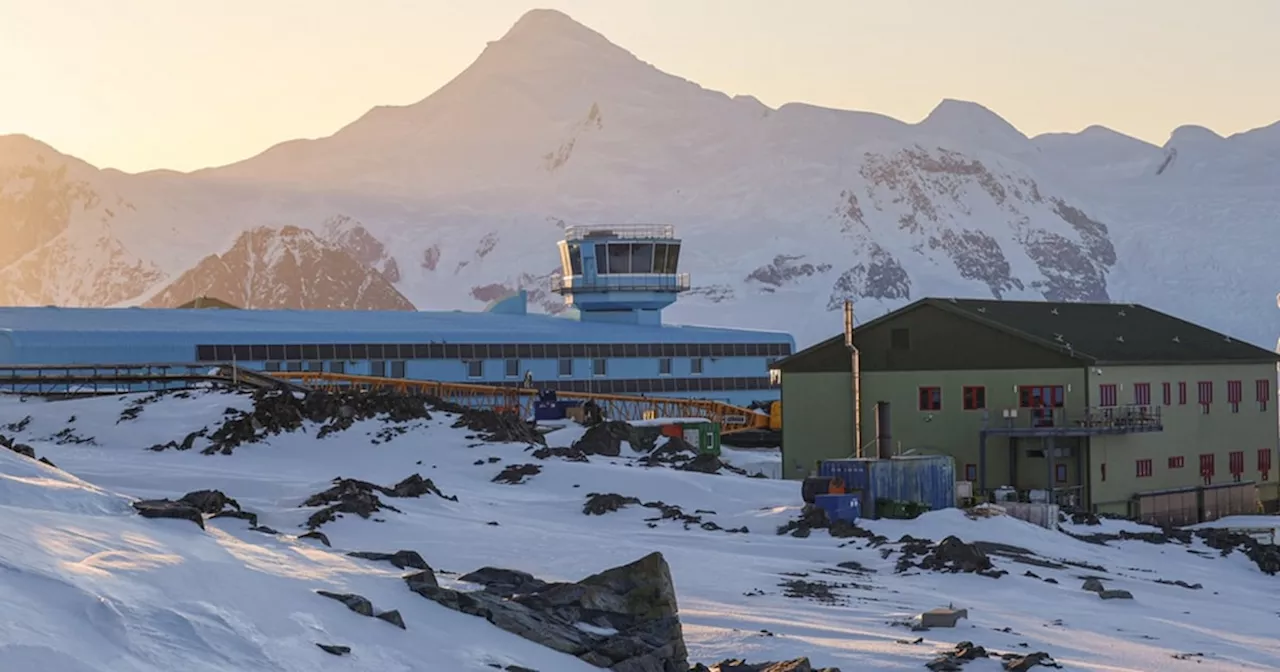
left=196, top=343, right=791, bottom=362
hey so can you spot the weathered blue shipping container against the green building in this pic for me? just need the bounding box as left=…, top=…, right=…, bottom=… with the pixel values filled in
left=818, top=456, right=956, bottom=518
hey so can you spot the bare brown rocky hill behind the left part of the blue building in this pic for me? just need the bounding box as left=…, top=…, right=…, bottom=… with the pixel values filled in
left=143, top=220, right=415, bottom=310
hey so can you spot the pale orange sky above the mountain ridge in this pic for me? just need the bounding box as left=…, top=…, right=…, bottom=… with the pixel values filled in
left=0, top=0, right=1280, bottom=172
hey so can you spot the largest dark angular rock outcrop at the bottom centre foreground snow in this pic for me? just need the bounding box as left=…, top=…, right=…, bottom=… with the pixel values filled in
left=410, top=553, right=689, bottom=672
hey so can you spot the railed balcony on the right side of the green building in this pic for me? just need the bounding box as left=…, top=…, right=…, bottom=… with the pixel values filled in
left=982, top=406, right=1165, bottom=436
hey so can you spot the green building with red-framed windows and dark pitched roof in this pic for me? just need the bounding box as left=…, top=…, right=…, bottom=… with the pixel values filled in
left=773, top=298, right=1280, bottom=524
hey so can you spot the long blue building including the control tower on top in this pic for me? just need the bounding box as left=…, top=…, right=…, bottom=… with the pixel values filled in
left=0, top=225, right=795, bottom=406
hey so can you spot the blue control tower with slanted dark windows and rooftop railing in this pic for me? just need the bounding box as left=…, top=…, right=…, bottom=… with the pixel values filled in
left=552, top=224, right=689, bottom=325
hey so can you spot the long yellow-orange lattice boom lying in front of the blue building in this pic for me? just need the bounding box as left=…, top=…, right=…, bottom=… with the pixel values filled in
left=258, top=371, right=769, bottom=431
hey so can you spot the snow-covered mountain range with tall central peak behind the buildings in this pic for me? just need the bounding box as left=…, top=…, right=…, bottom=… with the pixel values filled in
left=0, top=10, right=1280, bottom=346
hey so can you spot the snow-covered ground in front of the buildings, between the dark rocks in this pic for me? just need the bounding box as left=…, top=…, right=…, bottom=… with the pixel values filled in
left=0, top=384, right=1280, bottom=672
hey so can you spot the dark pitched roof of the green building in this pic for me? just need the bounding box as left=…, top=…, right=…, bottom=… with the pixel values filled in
left=773, top=298, right=1280, bottom=370
